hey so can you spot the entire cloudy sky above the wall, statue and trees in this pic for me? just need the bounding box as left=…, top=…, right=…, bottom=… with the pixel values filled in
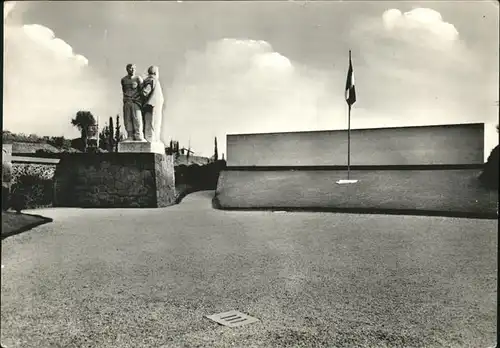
left=3, top=1, right=499, bottom=155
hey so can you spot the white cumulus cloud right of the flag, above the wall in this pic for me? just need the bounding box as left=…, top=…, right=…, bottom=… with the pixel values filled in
left=351, top=8, right=498, bottom=119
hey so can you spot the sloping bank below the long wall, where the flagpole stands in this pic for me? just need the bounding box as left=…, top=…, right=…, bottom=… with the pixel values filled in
left=215, top=169, right=498, bottom=218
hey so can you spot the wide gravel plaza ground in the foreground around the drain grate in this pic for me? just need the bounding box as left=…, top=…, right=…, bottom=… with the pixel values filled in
left=1, top=191, right=498, bottom=348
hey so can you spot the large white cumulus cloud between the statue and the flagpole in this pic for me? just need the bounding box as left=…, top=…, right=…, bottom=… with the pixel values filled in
left=163, top=39, right=347, bottom=154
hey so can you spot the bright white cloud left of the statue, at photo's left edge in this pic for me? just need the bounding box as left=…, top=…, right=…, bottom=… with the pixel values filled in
left=3, top=3, right=113, bottom=136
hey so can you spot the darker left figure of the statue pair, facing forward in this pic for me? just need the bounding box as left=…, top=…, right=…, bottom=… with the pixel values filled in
left=121, top=64, right=145, bottom=141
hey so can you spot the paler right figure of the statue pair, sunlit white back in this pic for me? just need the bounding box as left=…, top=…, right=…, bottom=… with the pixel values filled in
left=142, top=66, right=164, bottom=142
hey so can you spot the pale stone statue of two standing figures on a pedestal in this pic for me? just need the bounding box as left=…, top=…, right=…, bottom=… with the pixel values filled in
left=121, top=64, right=164, bottom=143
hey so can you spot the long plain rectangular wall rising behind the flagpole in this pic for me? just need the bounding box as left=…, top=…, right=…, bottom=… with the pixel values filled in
left=227, top=123, right=484, bottom=167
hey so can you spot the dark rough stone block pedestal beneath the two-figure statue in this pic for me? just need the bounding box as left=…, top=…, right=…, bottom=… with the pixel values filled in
left=54, top=153, right=176, bottom=208
